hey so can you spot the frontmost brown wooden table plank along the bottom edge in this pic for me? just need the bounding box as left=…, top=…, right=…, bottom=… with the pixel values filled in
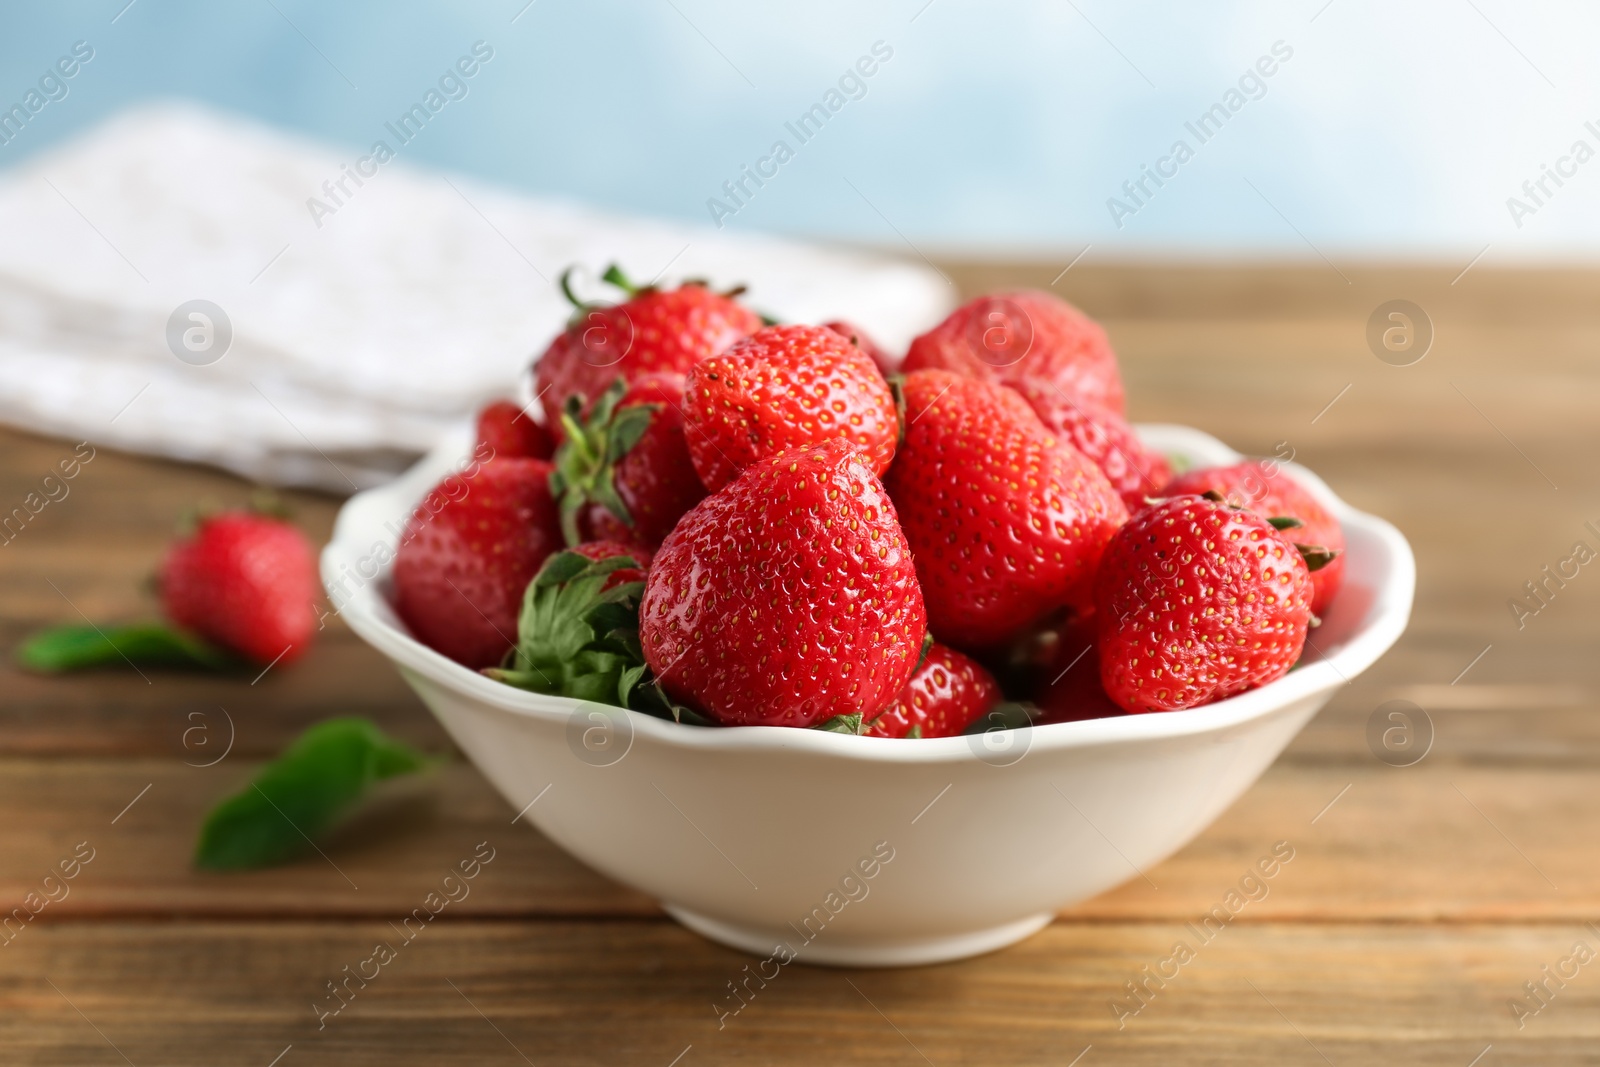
left=0, top=912, right=1600, bottom=1067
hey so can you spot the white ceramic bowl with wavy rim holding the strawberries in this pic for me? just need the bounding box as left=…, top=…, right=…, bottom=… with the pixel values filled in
left=322, top=426, right=1416, bottom=966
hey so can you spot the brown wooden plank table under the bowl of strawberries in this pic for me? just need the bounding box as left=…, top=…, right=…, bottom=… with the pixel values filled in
left=0, top=261, right=1600, bottom=1067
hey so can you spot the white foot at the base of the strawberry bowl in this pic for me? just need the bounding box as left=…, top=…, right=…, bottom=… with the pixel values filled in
left=661, top=904, right=1054, bottom=966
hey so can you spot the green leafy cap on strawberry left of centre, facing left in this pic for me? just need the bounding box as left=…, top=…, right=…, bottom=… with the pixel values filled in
left=550, top=378, right=661, bottom=545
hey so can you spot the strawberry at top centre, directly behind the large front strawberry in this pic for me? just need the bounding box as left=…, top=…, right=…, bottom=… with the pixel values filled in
left=683, top=326, right=899, bottom=493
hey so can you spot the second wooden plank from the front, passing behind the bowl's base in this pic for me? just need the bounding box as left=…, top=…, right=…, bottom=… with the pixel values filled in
left=0, top=758, right=1600, bottom=923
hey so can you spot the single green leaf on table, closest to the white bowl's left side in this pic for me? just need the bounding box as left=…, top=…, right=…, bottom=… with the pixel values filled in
left=194, top=718, right=434, bottom=870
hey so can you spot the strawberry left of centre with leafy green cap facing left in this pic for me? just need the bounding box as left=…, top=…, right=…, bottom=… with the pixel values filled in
left=550, top=374, right=706, bottom=547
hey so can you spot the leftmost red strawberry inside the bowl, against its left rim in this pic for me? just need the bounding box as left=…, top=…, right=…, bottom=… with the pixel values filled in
left=394, top=458, right=562, bottom=669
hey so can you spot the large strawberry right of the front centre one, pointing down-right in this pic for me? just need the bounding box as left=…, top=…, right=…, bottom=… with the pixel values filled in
left=885, top=371, right=1128, bottom=648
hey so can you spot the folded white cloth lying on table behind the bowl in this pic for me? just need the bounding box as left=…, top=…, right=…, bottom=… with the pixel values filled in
left=0, top=104, right=954, bottom=493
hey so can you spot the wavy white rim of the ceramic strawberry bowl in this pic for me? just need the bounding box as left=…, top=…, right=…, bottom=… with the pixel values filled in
left=322, top=424, right=1416, bottom=765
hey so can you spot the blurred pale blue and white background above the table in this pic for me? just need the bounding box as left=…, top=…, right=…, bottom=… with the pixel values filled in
left=0, top=0, right=1600, bottom=264
